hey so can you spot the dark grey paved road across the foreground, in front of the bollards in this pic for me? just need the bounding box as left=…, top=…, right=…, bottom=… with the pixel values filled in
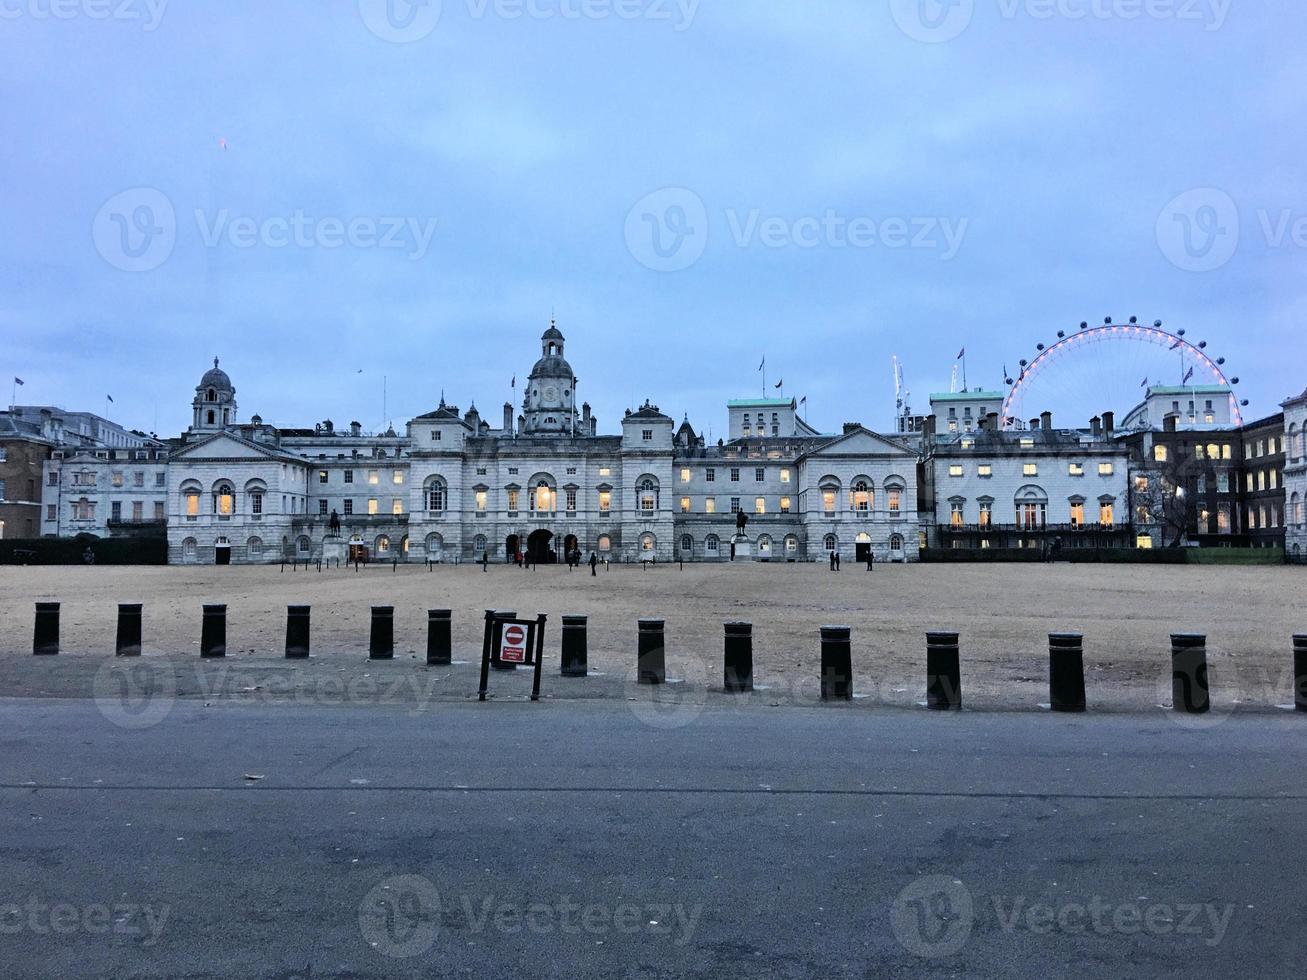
left=0, top=700, right=1307, bottom=980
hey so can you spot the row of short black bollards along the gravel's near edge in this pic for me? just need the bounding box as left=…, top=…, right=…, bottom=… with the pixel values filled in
left=17, top=602, right=1307, bottom=715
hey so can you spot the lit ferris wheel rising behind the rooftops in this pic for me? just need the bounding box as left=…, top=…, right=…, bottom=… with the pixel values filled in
left=1002, top=316, right=1248, bottom=429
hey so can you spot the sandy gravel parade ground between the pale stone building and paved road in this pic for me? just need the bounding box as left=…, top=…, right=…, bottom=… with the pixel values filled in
left=0, top=562, right=1307, bottom=713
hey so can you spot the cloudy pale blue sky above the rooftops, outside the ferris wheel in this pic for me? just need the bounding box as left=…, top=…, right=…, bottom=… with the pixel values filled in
left=0, top=0, right=1307, bottom=435
